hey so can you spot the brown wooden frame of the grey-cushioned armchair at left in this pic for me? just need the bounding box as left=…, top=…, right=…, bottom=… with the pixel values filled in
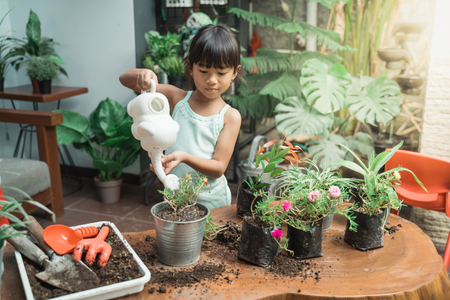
left=0, top=109, right=64, bottom=216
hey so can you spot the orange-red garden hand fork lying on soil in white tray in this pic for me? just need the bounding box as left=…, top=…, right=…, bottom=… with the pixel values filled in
left=73, top=226, right=112, bottom=267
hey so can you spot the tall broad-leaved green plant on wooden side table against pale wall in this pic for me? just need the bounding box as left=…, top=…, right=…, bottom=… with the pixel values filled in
left=8, top=10, right=67, bottom=92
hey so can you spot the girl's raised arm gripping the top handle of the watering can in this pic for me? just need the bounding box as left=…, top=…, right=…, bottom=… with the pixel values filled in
left=119, top=69, right=187, bottom=111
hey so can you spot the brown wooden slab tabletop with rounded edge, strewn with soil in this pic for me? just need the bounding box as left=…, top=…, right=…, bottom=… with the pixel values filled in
left=1, top=205, right=450, bottom=300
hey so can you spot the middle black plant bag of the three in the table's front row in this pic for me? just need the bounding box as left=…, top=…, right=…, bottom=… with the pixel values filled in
left=288, top=219, right=323, bottom=259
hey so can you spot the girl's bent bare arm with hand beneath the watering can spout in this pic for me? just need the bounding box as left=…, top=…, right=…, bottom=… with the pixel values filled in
left=162, top=108, right=241, bottom=178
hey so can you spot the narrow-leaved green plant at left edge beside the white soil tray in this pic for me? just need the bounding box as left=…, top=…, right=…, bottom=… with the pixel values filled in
left=0, top=171, right=55, bottom=289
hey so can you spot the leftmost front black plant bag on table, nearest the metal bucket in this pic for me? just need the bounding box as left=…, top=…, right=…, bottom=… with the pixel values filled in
left=238, top=217, right=279, bottom=267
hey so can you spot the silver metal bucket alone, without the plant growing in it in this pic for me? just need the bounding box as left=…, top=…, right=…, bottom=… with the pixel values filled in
left=150, top=202, right=209, bottom=267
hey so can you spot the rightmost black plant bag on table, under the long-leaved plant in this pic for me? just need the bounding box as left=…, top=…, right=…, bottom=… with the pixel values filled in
left=344, top=210, right=385, bottom=251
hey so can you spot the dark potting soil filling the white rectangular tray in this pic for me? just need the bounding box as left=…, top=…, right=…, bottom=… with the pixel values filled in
left=22, top=225, right=142, bottom=300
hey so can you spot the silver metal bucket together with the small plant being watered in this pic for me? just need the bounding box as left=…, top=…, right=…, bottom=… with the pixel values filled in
left=150, top=173, right=209, bottom=266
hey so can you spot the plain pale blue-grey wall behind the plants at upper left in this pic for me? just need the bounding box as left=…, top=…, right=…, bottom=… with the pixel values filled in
left=0, top=0, right=139, bottom=174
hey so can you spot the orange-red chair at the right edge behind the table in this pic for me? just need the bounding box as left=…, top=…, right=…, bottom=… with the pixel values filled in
left=385, top=149, right=450, bottom=271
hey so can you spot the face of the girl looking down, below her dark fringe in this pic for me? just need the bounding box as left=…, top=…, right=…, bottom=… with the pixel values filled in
left=191, top=63, right=241, bottom=98
